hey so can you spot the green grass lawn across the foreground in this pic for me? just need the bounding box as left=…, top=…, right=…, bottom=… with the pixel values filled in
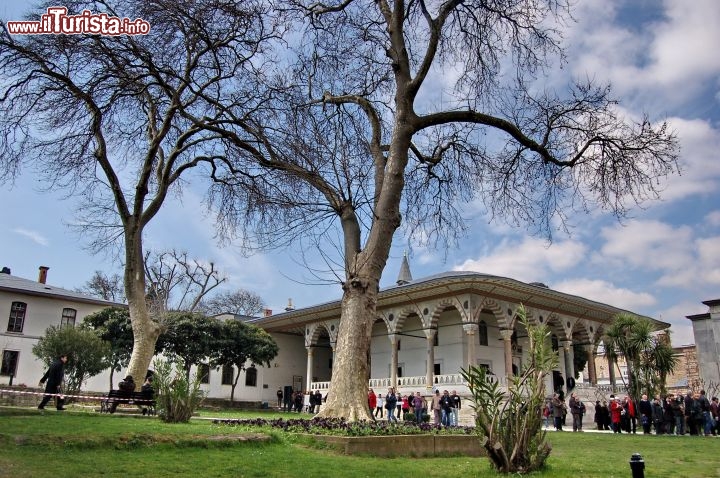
left=0, top=407, right=720, bottom=478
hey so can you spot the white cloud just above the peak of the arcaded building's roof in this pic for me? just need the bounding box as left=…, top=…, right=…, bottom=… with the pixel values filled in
left=455, top=238, right=587, bottom=282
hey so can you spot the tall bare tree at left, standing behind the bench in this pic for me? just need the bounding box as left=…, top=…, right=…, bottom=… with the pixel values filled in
left=0, top=0, right=277, bottom=386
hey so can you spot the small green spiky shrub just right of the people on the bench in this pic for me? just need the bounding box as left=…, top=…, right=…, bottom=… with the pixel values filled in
left=153, top=360, right=205, bottom=423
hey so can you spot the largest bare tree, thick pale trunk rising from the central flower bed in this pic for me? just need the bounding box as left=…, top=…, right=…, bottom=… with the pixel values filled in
left=205, top=0, right=677, bottom=420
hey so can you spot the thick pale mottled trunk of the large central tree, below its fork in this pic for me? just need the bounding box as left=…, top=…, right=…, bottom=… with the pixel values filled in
left=317, top=281, right=378, bottom=421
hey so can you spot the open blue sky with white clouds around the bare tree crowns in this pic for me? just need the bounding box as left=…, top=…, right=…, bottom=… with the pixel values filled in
left=0, top=0, right=720, bottom=346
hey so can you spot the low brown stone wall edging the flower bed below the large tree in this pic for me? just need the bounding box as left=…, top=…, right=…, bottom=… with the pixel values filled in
left=309, top=435, right=484, bottom=457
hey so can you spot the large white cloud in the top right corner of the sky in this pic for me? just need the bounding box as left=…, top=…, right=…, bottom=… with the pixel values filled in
left=568, top=0, right=720, bottom=107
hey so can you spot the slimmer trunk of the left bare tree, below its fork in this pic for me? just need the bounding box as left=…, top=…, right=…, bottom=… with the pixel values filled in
left=125, top=225, right=160, bottom=386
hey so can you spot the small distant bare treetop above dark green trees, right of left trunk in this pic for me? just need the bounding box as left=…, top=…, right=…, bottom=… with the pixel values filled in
left=144, top=250, right=227, bottom=312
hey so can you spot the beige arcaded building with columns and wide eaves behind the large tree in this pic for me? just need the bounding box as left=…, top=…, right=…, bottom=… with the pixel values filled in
left=252, top=261, right=669, bottom=400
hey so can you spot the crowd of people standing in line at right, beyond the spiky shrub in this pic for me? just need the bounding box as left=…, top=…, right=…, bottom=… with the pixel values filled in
left=543, top=390, right=720, bottom=436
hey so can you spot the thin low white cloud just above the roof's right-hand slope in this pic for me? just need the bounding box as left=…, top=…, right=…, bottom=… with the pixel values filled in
left=552, top=278, right=657, bottom=311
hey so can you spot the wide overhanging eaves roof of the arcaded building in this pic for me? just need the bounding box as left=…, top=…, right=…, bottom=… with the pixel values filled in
left=252, top=271, right=670, bottom=334
